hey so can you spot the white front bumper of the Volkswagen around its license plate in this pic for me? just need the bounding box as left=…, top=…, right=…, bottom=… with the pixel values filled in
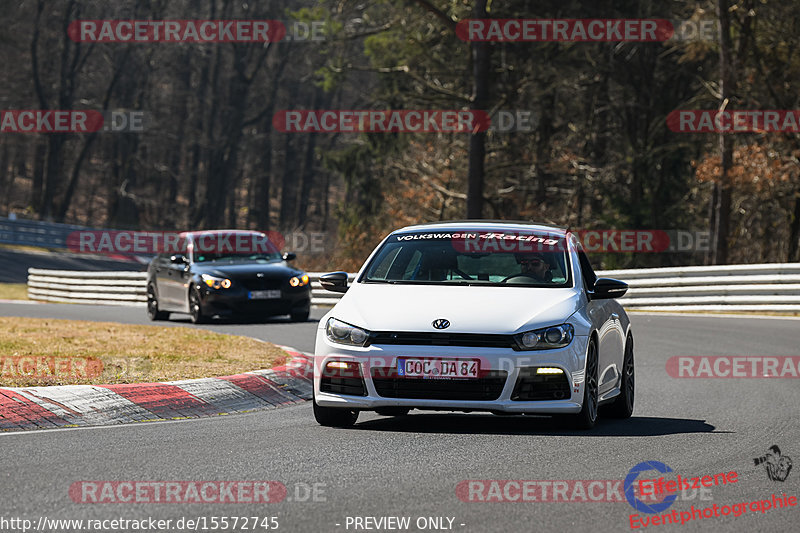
left=314, top=329, right=588, bottom=414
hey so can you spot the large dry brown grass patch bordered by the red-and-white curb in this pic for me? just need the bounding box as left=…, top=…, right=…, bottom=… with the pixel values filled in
left=0, top=317, right=289, bottom=387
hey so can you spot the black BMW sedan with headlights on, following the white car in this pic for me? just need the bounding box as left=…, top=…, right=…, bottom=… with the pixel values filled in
left=147, top=230, right=311, bottom=324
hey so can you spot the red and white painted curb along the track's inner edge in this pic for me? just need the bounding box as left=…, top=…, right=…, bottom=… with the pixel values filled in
left=0, top=346, right=313, bottom=431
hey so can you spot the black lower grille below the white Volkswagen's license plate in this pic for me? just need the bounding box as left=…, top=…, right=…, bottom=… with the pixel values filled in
left=372, top=368, right=508, bottom=401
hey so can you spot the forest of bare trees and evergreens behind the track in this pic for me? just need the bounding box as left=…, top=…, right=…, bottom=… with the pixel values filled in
left=0, top=0, right=800, bottom=270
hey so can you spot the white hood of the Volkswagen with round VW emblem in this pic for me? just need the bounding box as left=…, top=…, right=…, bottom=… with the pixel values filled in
left=328, top=283, right=582, bottom=333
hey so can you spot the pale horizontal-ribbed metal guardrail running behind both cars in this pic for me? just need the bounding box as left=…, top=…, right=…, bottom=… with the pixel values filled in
left=28, top=263, right=800, bottom=312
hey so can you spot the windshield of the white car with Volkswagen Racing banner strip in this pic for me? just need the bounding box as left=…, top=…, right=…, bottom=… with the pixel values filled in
left=360, top=231, right=572, bottom=287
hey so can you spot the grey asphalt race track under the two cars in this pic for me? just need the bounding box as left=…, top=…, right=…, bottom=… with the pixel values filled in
left=0, top=303, right=800, bottom=532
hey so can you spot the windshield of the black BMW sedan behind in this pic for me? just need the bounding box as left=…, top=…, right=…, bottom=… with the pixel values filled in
left=192, top=233, right=282, bottom=263
